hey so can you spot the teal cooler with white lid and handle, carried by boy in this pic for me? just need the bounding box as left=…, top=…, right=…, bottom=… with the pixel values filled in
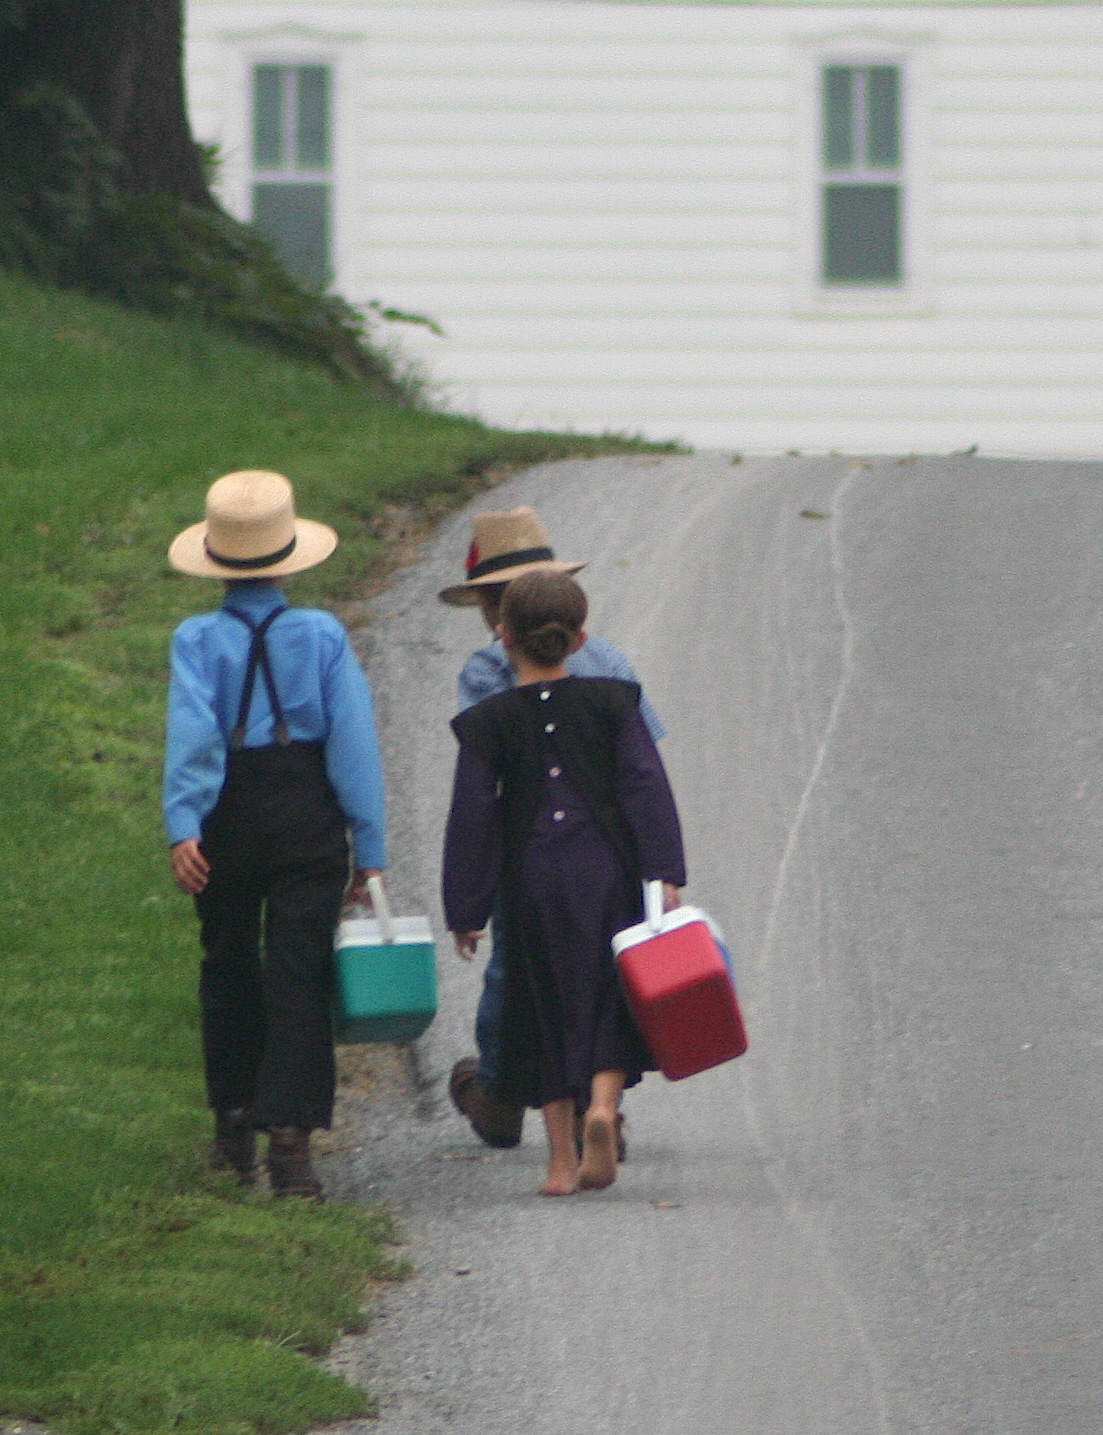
left=334, top=891, right=436, bottom=1043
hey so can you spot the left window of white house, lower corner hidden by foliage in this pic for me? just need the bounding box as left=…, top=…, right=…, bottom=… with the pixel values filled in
left=252, top=65, right=333, bottom=286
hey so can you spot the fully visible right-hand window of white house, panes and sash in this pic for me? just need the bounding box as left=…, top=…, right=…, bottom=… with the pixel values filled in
left=820, top=65, right=904, bottom=287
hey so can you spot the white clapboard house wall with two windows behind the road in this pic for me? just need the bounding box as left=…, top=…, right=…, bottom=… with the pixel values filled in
left=186, top=0, right=1103, bottom=455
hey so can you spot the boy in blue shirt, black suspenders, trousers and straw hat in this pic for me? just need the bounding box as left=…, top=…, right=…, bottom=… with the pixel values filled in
left=165, top=471, right=384, bottom=1200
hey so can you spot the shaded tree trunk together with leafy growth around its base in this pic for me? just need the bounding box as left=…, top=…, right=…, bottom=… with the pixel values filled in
left=0, top=0, right=413, bottom=403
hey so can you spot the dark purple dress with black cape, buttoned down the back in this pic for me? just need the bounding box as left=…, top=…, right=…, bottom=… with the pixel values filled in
left=443, top=677, right=686, bottom=1109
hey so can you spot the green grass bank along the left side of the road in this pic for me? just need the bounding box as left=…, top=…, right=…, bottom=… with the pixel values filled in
left=0, top=274, right=671, bottom=1435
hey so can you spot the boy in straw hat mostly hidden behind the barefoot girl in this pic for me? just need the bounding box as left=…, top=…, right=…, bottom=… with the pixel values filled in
left=439, top=507, right=666, bottom=1155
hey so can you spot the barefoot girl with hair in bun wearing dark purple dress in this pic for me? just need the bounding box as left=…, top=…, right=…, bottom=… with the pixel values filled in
left=443, top=571, right=686, bottom=1195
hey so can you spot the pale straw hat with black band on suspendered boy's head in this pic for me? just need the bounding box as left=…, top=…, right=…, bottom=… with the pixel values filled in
left=168, top=469, right=337, bottom=578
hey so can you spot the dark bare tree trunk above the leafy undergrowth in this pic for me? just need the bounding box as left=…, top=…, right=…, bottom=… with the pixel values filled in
left=0, top=0, right=212, bottom=207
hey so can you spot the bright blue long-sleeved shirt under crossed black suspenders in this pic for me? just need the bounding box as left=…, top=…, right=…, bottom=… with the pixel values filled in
left=164, top=583, right=386, bottom=868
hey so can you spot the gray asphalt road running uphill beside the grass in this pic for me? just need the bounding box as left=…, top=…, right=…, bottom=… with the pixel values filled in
left=315, top=455, right=1103, bottom=1435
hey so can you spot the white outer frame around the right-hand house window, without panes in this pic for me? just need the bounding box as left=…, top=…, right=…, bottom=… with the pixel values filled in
left=793, top=30, right=932, bottom=317
